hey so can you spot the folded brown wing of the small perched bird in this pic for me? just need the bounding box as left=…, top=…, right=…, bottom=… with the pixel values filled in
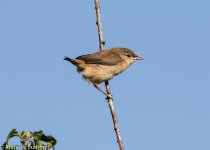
left=76, top=51, right=121, bottom=66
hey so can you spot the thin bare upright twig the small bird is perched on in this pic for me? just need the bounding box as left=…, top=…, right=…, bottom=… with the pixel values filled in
left=94, top=0, right=124, bottom=150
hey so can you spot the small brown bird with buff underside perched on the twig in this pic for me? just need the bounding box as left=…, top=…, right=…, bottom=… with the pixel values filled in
left=64, top=48, right=143, bottom=97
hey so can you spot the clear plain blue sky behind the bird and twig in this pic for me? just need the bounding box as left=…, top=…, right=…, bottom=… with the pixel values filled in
left=0, top=0, right=210, bottom=150
